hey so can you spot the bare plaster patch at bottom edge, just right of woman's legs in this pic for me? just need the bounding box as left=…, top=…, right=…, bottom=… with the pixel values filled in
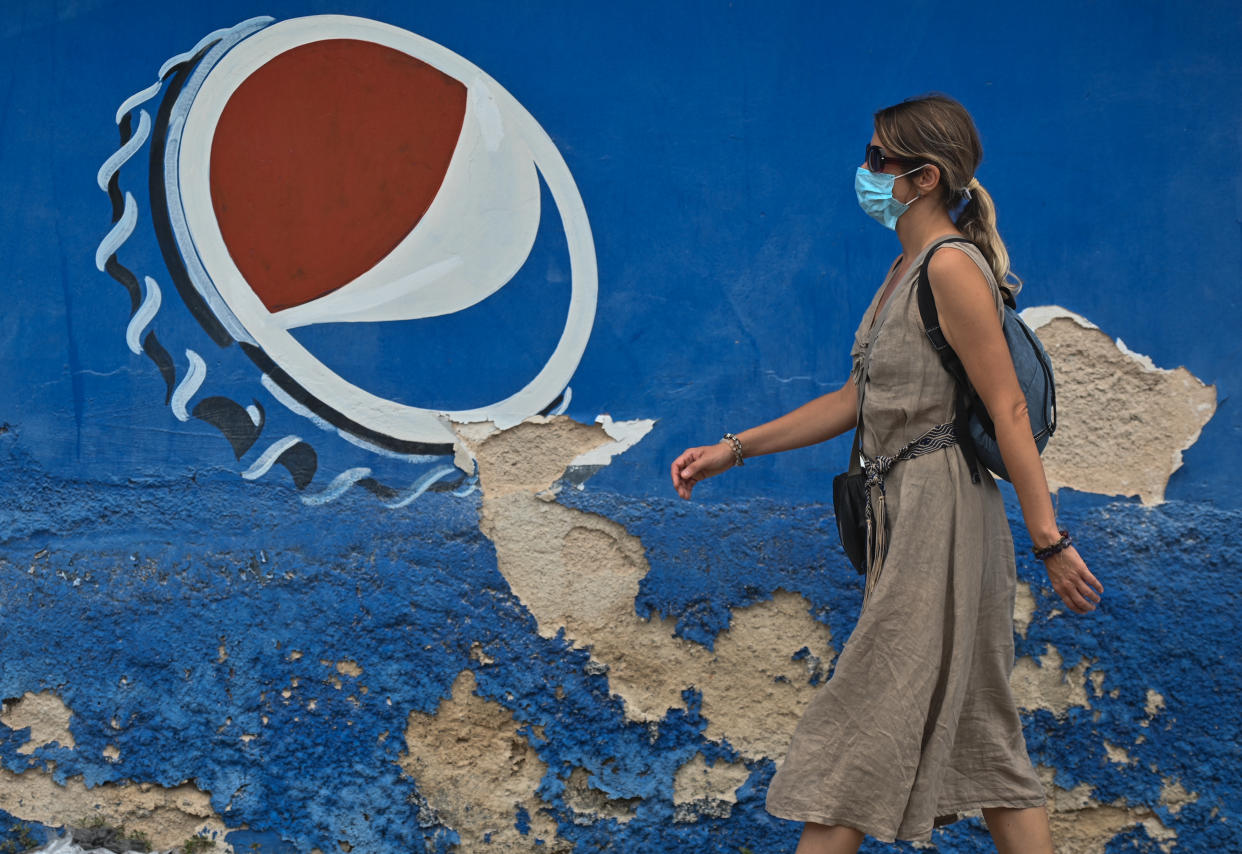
left=1037, top=767, right=1177, bottom=854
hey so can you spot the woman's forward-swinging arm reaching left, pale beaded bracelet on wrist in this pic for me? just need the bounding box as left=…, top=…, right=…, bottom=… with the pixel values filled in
left=672, top=380, right=858, bottom=498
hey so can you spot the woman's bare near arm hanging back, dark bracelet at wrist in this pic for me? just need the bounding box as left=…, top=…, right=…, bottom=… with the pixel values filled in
left=928, top=252, right=1104, bottom=613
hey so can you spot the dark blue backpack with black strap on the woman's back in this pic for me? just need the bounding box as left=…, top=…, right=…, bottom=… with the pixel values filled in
left=918, top=237, right=1057, bottom=483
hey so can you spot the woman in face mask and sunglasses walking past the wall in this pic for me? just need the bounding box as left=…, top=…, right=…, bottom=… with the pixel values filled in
left=672, top=94, right=1103, bottom=854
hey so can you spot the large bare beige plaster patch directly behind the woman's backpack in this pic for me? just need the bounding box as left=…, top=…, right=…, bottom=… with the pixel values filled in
left=1022, top=305, right=1216, bottom=505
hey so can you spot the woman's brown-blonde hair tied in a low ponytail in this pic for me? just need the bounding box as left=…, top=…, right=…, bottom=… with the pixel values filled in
left=876, top=93, right=1022, bottom=295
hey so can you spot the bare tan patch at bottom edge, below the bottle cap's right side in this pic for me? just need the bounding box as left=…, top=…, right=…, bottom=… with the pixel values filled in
left=400, top=670, right=573, bottom=854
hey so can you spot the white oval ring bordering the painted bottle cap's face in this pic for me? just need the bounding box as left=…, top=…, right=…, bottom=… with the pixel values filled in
left=177, top=15, right=599, bottom=443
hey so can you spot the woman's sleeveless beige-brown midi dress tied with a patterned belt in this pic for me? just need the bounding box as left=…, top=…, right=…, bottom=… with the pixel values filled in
left=768, top=243, right=1045, bottom=842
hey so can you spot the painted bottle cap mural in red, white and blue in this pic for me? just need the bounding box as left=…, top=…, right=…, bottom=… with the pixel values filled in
left=96, top=15, right=597, bottom=506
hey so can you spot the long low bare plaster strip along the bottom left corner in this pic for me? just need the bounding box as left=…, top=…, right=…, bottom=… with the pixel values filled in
left=0, top=768, right=236, bottom=854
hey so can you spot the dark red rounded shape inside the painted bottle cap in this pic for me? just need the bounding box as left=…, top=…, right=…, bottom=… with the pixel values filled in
left=210, top=38, right=466, bottom=313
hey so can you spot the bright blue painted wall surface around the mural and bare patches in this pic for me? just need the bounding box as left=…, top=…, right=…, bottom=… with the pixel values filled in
left=0, top=0, right=1242, bottom=852
